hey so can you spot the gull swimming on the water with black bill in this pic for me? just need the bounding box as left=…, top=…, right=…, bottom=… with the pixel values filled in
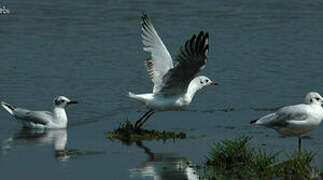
left=0, top=96, right=77, bottom=129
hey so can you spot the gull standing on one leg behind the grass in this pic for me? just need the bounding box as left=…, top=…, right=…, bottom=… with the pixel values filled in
left=250, top=92, right=323, bottom=152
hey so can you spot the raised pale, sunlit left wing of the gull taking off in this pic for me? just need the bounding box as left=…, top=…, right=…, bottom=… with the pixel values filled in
left=141, top=15, right=173, bottom=93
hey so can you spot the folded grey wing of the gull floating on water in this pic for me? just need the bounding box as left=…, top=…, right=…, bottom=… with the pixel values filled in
left=14, top=108, right=53, bottom=125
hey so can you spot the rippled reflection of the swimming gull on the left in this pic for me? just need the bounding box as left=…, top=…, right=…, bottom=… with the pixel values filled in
left=1, top=128, right=103, bottom=161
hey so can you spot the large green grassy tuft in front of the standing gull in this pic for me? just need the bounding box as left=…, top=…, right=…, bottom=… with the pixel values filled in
left=195, top=136, right=319, bottom=179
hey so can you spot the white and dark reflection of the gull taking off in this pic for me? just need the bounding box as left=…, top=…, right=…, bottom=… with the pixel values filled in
left=130, top=142, right=199, bottom=180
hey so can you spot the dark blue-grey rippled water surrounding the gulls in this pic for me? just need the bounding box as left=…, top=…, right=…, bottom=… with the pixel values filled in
left=0, top=0, right=323, bottom=179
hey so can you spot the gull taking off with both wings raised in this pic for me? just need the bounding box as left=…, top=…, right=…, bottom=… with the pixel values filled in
left=129, top=15, right=217, bottom=129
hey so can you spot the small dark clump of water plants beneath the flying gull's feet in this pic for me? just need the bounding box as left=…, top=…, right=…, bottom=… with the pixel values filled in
left=108, top=120, right=186, bottom=143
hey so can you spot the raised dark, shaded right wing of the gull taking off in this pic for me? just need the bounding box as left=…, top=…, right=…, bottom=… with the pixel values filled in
left=159, top=31, right=209, bottom=96
